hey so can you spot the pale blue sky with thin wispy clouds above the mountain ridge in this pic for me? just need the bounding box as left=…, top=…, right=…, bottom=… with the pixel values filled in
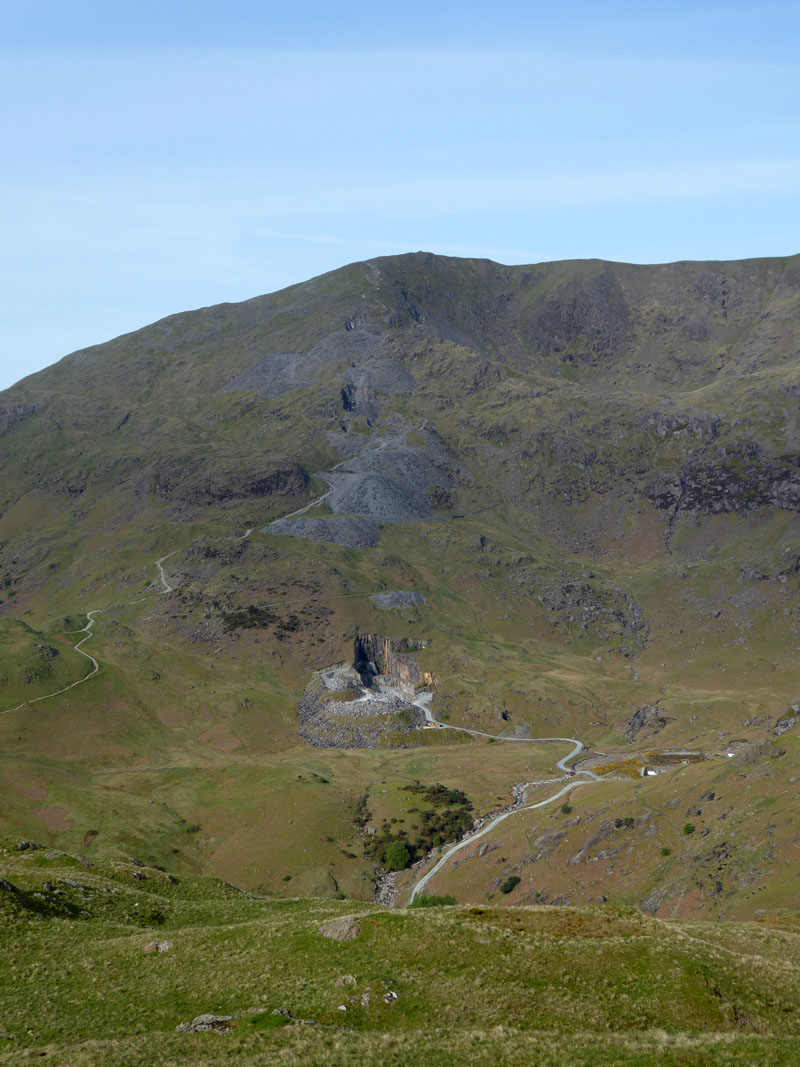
left=0, top=0, right=800, bottom=387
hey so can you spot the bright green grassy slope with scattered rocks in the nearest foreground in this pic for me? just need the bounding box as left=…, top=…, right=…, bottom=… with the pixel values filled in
left=0, top=843, right=800, bottom=1067
